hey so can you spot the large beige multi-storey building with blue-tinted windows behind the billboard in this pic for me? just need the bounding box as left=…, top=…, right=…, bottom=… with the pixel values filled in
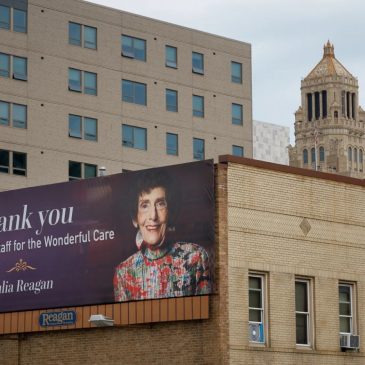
left=0, top=0, right=252, bottom=191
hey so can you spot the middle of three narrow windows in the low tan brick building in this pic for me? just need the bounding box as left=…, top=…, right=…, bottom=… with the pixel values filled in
left=295, top=279, right=311, bottom=345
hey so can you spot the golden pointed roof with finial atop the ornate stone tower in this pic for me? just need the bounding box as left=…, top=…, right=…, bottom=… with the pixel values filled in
left=305, top=41, right=354, bottom=80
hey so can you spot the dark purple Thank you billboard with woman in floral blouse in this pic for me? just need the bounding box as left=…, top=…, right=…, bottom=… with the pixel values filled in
left=0, top=160, right=215, bottom=313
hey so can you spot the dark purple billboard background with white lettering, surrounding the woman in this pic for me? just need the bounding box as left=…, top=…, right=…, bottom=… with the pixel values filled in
left=0, top=160, right=215, bottom=312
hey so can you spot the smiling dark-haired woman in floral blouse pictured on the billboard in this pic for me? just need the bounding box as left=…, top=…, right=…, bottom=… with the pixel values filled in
left=113, top=170, right=210, bottom=302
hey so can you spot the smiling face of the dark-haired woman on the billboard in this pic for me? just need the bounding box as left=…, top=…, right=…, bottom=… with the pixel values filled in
left=134, top=187, right=168, bottom=245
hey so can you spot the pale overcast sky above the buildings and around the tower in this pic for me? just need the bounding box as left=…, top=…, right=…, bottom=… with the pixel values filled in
left=89, top=0, right=365, bottom=143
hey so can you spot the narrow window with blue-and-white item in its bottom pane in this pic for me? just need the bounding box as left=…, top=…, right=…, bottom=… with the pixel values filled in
left=248, top=274, right=265, bottom=343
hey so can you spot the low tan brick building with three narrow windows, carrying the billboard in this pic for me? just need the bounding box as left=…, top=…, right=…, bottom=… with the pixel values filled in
left=0, top=156, right=365, bottom=365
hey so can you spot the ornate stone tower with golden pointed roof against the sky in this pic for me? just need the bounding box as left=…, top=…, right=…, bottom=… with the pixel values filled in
left=289, top=42, right=365, bottom=178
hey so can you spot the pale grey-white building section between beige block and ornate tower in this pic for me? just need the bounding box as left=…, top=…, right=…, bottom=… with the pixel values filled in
left=253, top=120, right=290, bottom=165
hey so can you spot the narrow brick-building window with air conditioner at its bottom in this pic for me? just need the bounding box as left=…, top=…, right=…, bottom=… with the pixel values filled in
left=338, top=283, right=355, bottom=334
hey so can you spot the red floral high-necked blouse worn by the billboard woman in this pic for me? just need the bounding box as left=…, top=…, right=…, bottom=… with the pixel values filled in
left=114, top=242, right=210, bottom=302
